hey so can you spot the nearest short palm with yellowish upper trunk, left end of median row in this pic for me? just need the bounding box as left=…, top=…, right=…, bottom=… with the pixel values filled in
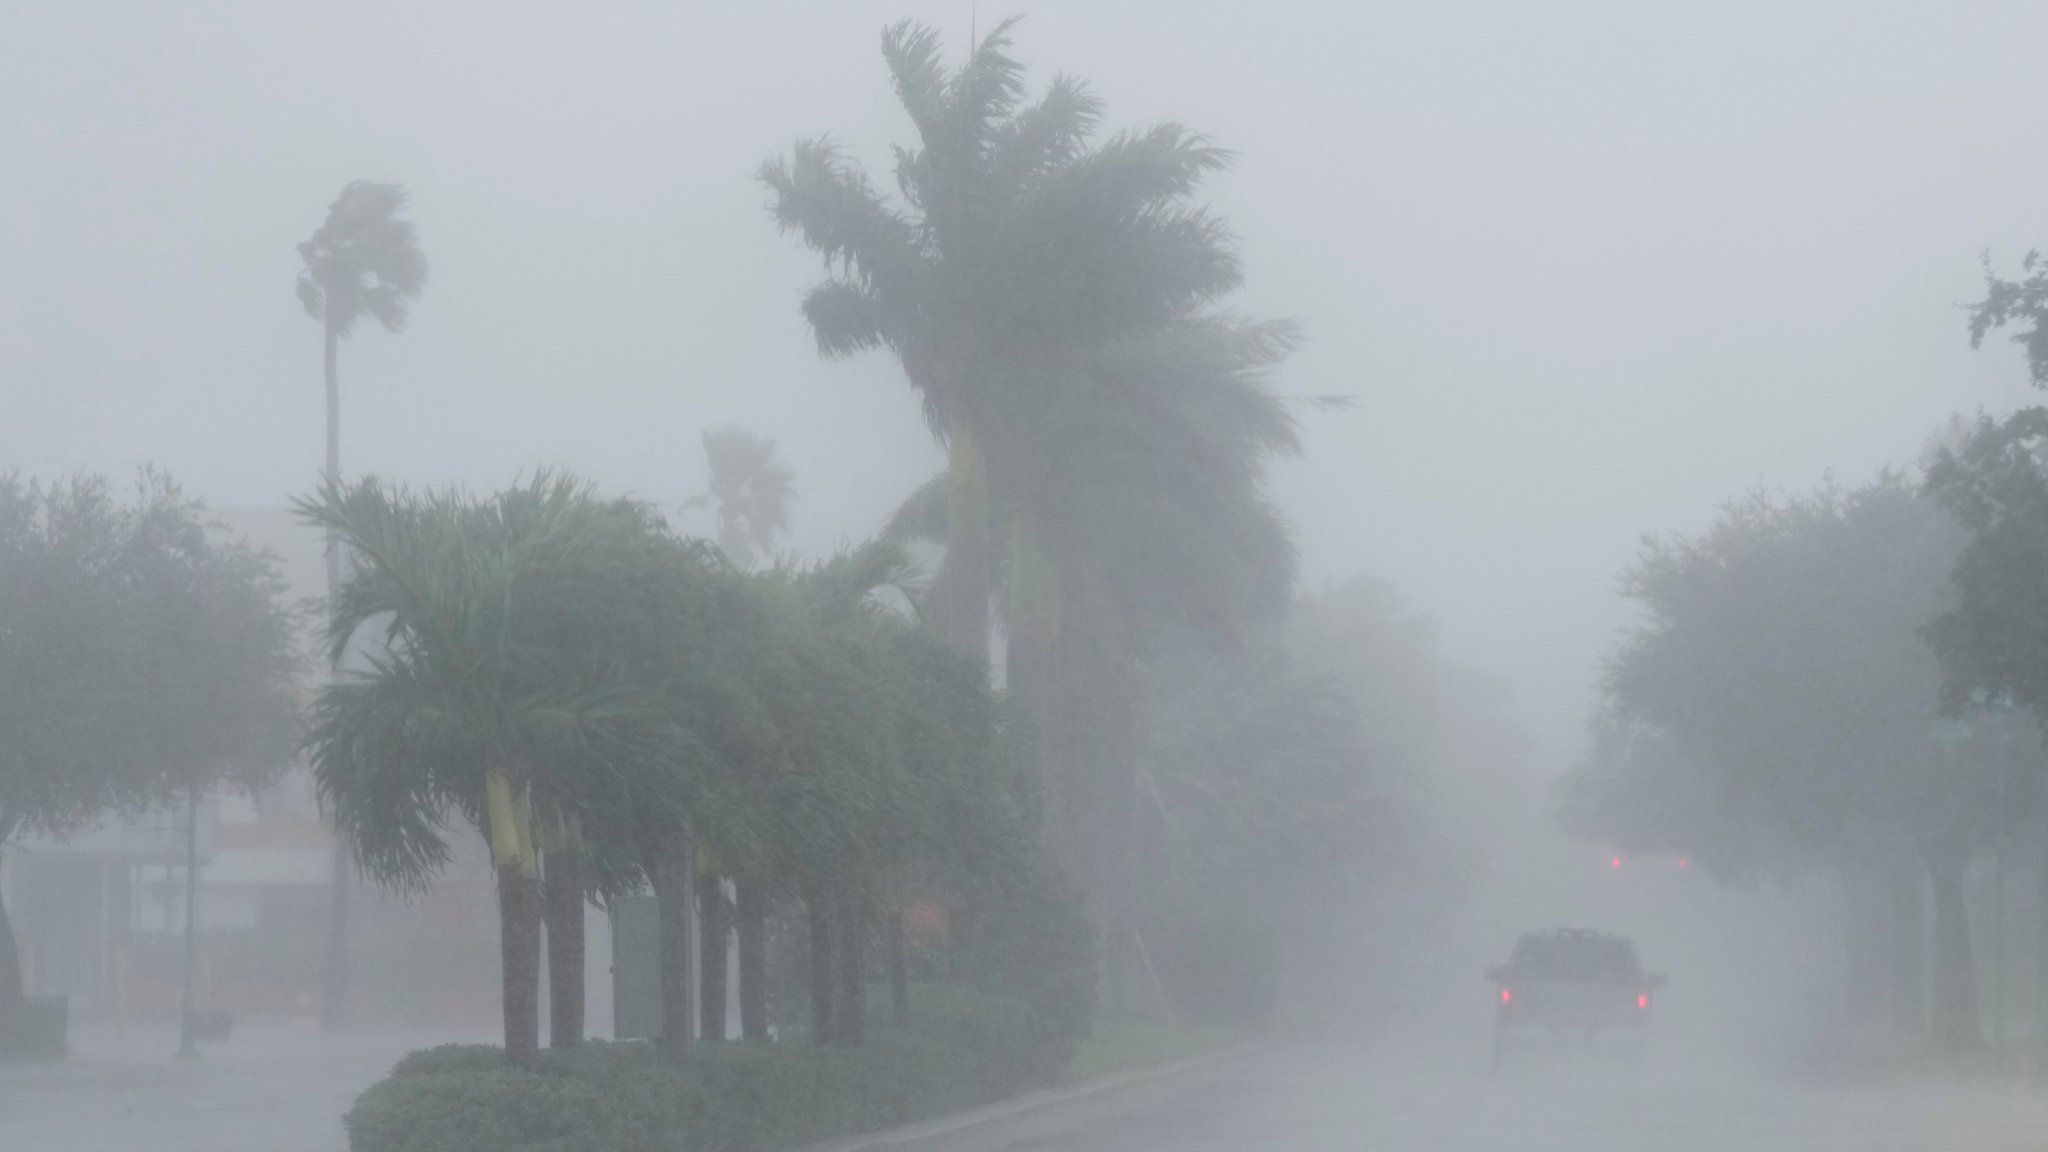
left=299, top=476, right=688, bottom=1062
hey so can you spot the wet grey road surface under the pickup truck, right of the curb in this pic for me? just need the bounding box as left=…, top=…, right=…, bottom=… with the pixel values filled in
left=921, top=1045, right=2048, bottom=1152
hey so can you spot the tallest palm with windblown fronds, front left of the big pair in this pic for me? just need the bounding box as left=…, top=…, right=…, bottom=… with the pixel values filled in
left=760, top=20, right=1241, bottom=658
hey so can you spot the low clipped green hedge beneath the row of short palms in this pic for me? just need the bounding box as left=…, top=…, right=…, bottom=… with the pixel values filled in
left=342, top=986, right=1073, bottom=1152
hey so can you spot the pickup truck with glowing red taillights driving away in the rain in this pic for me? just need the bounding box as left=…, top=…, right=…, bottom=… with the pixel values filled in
left=1487, top=929, right=1665, bottom=1066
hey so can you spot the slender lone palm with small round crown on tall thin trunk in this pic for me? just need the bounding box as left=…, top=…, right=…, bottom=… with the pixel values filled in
left=299, top=180, right=426, bottom=1027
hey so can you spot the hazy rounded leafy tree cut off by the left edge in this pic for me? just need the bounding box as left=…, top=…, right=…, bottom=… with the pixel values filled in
left=0, top=471, right=297, bottom=1047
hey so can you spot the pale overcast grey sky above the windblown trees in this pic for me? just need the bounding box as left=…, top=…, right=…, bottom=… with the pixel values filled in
left=0, top=0, right=2048, bottom=767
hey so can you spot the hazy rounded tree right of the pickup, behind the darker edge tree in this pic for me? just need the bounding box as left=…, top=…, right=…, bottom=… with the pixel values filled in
left=1579, top=476, right=2025, bottom=1052
